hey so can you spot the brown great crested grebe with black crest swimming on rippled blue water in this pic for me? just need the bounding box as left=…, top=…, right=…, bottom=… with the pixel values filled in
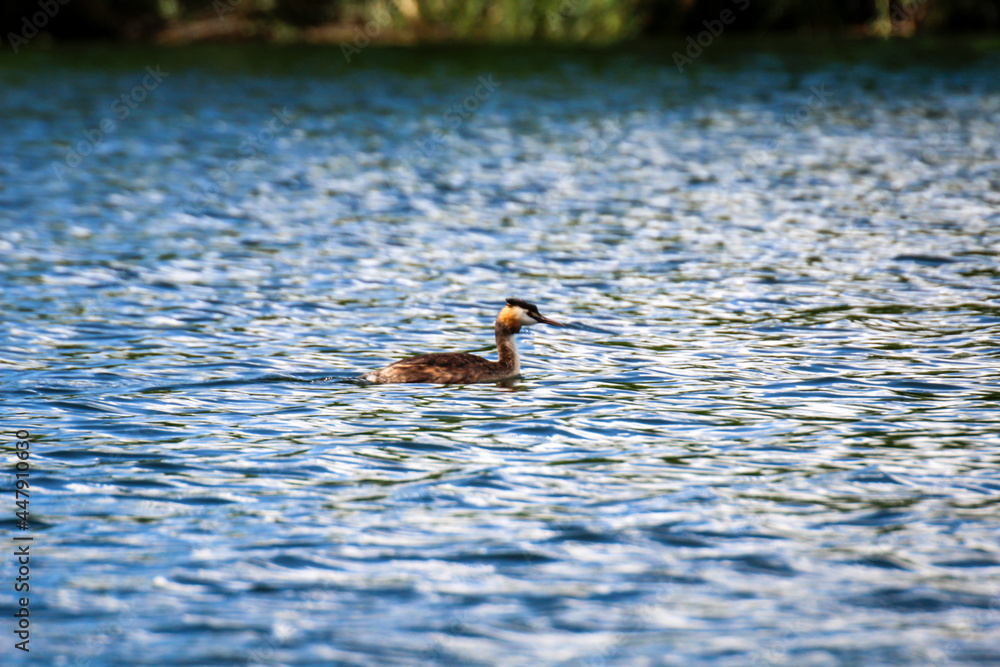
left=361, top=298, right=563, bottom=384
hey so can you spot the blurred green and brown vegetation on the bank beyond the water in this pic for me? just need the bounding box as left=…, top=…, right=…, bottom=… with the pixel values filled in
left=0, top=0, right=1000, bottom=45
